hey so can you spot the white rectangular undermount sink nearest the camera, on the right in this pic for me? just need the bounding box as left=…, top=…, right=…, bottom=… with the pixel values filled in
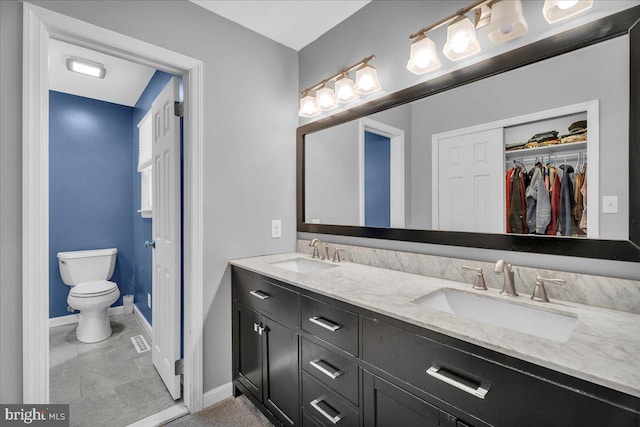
left=413, top=288, right=577, bottom=342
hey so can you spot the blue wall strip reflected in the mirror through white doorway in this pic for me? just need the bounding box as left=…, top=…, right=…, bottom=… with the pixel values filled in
left=364, top=132, right=391, bottom=227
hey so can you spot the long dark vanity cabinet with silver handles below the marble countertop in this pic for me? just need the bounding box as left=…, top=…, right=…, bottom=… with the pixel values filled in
left=233, top=267, right=640, bottom=427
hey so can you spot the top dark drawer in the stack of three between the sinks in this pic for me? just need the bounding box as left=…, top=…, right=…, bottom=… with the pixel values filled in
left=302, top=297, right=358, bottom=356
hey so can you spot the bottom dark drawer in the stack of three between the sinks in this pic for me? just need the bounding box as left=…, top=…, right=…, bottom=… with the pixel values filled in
left=302, top=372, right=359, bottom=427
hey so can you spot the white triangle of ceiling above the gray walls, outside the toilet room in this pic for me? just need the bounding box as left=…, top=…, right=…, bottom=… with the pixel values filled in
left=190, top=0, right=371, bottom=51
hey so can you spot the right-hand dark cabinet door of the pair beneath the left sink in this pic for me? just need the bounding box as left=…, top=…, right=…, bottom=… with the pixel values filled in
left=262, top=316, right=300, bottom=426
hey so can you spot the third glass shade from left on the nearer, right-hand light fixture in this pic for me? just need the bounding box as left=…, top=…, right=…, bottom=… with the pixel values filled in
left=487, top=0, right=529, bottom=44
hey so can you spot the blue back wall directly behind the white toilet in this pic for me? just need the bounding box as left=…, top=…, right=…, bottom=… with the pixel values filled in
left=49, top=91, right=135, bottom=318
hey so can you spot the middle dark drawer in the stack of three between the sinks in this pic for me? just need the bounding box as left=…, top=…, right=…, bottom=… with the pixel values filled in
left=302, top=338, right=358, bottom=405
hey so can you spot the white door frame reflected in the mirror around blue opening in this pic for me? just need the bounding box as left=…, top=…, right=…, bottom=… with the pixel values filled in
left=358, top=117, right=405, bottom=228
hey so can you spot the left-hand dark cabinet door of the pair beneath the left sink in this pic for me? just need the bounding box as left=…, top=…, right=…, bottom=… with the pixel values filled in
left=234, top=304, right=262, bottom=402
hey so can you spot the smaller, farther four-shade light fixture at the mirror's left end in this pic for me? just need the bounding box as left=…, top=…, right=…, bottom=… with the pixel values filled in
left=298, top=55, right=381, bottom=117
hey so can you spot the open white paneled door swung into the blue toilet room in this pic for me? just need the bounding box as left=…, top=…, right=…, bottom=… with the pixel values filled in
left=151, top=77, right=181, bottom=399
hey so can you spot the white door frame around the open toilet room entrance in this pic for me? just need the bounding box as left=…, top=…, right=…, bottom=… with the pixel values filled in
left=22, top=2, right=204, bottom=413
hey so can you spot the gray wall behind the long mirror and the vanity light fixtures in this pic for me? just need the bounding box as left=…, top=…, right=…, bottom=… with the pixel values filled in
left=298, top=0, right=640, bottom=279
